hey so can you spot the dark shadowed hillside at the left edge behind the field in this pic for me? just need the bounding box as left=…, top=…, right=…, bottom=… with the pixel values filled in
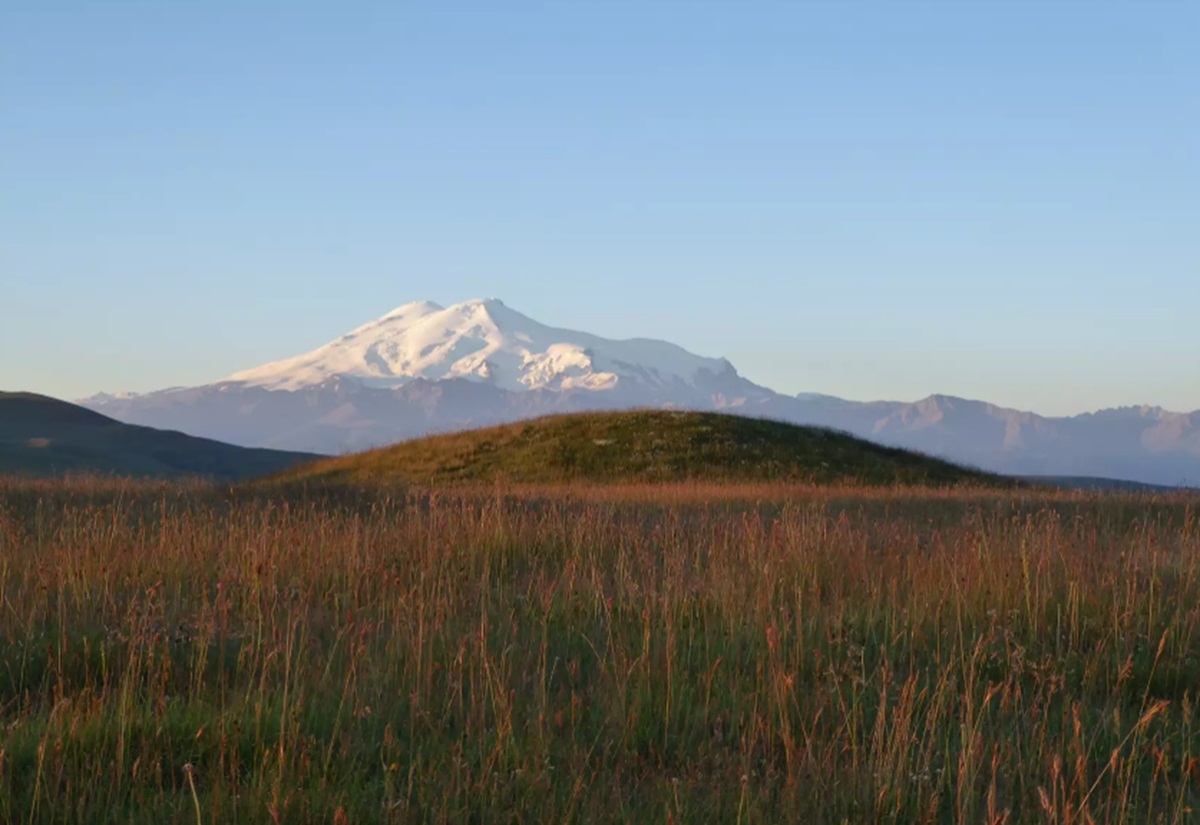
left=0, top=392, right=316, bottom=480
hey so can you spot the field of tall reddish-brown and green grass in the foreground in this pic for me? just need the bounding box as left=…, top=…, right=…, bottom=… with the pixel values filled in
left=0, top=480, right=1200, bottom=825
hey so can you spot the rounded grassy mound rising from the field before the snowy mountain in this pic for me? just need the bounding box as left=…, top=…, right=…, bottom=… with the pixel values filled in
left=284, top=410, right=1012, bottom=486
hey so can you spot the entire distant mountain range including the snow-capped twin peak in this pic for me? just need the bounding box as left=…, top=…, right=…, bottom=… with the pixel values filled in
left=80, top=299, right=1200, bottom=486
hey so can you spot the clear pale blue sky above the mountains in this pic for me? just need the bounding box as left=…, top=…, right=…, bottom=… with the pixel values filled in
left=0, top=0, right=1200, bottom=413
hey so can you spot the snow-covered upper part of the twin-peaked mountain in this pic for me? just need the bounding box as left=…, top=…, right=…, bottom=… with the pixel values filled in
left=228, top=299, right=737, bottom=392
